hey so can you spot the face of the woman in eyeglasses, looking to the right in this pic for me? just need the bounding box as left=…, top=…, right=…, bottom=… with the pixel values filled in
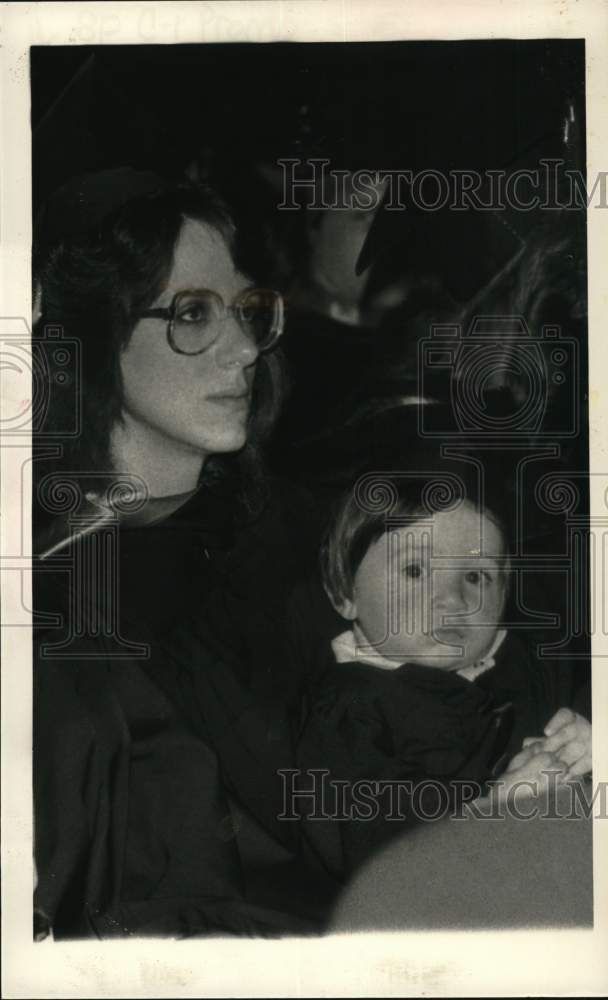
left=121, top=219, right=258, bottom=461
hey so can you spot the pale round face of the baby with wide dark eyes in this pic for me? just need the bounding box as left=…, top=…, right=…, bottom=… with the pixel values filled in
left=352, top=502, right=505, bottom=670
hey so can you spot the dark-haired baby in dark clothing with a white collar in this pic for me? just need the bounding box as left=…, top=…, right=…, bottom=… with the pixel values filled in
left=299, top=476, right=591, bottom=871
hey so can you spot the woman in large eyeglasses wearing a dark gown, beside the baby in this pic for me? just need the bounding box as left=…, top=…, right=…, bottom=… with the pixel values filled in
left=34, top=169, right=338, bottom=937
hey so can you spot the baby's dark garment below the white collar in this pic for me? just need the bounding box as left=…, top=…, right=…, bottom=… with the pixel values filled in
left=298, top=633, right=561, bottom=877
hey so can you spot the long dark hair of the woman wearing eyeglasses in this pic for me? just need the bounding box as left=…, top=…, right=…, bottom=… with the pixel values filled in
left=33, top=172, right=282, bottom=544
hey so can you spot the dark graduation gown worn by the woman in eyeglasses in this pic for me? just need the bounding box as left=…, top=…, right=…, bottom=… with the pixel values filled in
left=34, top=476, right=334, bottom=937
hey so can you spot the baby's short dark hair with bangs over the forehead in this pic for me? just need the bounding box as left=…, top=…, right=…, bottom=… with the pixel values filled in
left=321, top=463, right=510, bottom=607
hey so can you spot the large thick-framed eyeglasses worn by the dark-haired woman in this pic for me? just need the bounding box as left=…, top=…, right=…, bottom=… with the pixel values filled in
left=140, top=288, right=285, bottom=354
